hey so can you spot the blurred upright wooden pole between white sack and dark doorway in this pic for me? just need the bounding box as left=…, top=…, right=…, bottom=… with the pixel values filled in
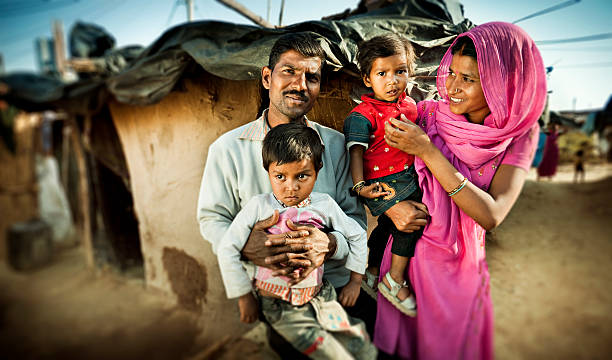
left=70, top=118, right=94, bottom=268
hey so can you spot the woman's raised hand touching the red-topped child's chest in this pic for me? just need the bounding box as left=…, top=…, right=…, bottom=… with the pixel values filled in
left=385, top=114, right=434, bottom=158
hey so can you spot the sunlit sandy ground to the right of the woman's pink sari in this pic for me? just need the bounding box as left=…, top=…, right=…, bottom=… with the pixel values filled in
left=487, top=166, right=612, bottom=359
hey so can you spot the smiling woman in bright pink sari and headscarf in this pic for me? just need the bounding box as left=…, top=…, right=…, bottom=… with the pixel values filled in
left=375, top=22, right=546, bottom=359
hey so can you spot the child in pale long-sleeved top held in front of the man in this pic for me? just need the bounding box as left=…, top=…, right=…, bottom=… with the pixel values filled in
left=217, top=123, right=377, bottom=359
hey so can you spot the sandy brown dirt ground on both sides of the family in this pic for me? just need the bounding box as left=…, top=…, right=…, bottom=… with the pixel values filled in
left=0, top=165, right=612, bottom=359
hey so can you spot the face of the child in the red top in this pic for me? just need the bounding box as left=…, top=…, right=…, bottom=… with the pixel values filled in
left=363, top=52, right=408, bottom=101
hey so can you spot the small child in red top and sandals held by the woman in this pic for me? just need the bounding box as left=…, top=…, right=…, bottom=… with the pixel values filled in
left=344, top=34, right=422, bottom=316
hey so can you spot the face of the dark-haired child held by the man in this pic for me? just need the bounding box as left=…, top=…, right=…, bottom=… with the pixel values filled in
left=268, top=159, right=317, bottom=206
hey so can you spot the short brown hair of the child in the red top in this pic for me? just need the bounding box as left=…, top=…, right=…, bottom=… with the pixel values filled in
left=357, top=33, right=415, bottom=76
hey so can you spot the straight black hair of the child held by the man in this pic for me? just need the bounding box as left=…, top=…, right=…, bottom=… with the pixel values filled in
left=261, top=122, right=324, bottom=171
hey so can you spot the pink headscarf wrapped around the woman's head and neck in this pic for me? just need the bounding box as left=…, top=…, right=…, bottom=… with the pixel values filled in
left=436, top=22, right=546, bottom=169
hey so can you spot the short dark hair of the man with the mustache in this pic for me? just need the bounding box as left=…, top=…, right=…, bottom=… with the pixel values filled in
left=268, top=32, right=325, bottom=71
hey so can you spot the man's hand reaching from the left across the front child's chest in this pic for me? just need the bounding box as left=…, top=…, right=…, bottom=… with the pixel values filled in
left=241, top=210, right=312, bottom=270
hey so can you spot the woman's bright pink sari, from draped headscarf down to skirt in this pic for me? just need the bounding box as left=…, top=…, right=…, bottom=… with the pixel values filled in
left=374, top=22, right=546, bottom=359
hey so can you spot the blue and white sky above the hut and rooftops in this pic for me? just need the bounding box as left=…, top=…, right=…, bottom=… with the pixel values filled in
left=0, top=0, right=612, bottom=110
